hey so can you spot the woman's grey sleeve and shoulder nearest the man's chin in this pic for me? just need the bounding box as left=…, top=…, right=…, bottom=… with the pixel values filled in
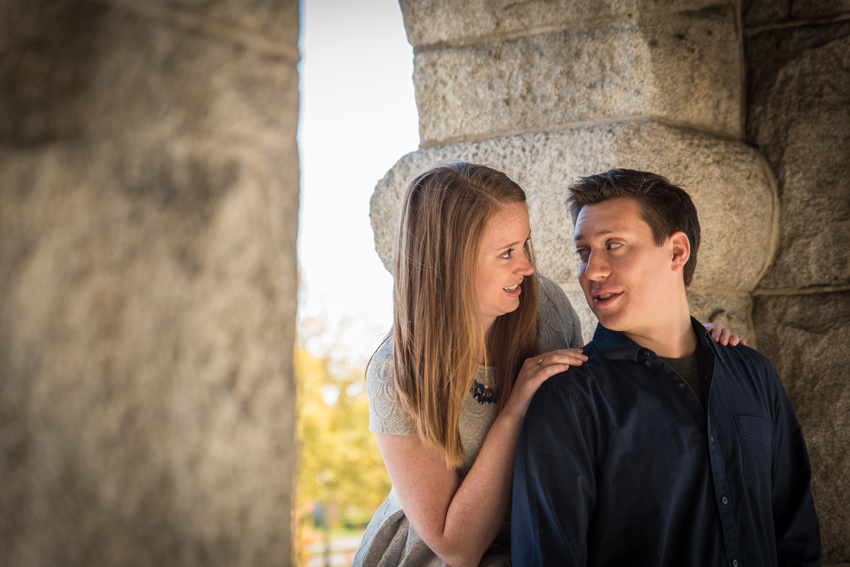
left=537, top=275, right=581, bottom=352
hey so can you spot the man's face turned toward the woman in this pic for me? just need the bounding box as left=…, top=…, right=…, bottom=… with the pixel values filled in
left=575, top=198, right=681, bottom=334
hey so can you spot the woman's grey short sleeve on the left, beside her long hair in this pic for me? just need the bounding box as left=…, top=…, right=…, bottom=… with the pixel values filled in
left=366, top=337, right=414, bottom=435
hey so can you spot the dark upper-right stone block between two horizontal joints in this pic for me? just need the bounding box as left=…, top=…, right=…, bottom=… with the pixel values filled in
left=746, top=22, right=850, bottom=288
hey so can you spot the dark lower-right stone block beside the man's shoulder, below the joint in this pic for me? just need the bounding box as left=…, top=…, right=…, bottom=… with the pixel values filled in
left=754, top=292, right=850, bottom=564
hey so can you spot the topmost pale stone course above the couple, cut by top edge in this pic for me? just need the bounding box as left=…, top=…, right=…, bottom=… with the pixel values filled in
left=399, top=0, right=732, bottom=47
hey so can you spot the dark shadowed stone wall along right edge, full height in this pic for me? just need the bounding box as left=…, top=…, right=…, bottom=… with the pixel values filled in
left=743, top=0, right=850, bottom=564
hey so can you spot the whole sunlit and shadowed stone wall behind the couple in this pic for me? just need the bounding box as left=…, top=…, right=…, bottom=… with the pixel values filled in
left=372, top=0, right=850, bottom=564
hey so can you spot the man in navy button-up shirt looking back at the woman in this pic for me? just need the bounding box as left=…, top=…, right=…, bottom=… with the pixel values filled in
left=511, top=170, right=821, bottom=567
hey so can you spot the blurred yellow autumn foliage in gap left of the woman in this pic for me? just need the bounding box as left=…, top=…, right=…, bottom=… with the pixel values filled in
left=295, top=321, right=391, bottom=560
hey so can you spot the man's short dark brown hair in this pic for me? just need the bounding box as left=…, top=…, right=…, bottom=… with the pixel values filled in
left=567, top=169, right=700, bottom=286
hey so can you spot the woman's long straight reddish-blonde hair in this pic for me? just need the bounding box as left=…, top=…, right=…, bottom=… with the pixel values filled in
left=393, top=162, right=537, bottom=468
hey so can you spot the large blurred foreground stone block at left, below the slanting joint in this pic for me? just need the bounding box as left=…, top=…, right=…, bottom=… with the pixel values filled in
left=0, top=0, right=298, bottom=567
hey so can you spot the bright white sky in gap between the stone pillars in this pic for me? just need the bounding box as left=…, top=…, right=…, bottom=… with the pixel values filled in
left=298, top=0, right=419, bottom=365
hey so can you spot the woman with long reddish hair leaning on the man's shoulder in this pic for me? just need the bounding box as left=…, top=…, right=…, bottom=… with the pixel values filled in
left=353, top=162, right=737, bottom=567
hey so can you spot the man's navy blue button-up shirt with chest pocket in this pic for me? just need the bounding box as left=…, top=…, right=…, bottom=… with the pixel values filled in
left=511, top=319, right=821, bottom=567
